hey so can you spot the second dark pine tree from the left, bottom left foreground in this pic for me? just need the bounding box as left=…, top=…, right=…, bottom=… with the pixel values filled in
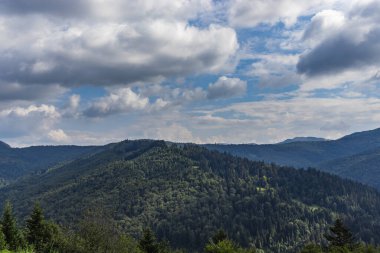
left=26, top=203, right=45, bottom=251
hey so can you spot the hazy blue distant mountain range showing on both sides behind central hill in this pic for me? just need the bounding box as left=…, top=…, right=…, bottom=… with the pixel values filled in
left=0, top=129, right=380, bottom=190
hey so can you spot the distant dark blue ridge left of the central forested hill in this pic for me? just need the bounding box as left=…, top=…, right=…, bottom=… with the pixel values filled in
left=0, top=142, right=103, bottom=185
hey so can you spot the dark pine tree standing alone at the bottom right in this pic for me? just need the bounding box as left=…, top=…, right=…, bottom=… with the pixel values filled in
left=324, top=219, right=355, bottom=248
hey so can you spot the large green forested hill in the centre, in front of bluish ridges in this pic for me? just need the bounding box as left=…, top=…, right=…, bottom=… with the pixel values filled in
left=0, top=140, right=380, bottom=252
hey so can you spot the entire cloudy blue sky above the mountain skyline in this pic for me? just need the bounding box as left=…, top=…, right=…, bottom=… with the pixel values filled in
left=0, top=0, right=380, bottom=147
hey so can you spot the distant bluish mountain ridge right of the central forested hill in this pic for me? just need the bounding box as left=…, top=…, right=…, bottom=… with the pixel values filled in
left=205, top=129, right=380, bottom=190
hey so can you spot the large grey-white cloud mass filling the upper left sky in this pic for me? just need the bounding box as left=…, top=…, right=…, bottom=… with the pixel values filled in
left=0, top=0, right=239, bottom=91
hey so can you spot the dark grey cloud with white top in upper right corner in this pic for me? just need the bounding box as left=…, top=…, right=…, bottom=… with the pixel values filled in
left=297, top=1, right=380, bottom=76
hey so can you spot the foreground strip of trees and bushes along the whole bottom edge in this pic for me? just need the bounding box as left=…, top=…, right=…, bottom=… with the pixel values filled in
left=0, top=202, right=380, bottom=253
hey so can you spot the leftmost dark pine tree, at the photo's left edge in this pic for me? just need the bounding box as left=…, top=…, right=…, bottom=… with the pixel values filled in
left=1, top=201, right=21, bottom=250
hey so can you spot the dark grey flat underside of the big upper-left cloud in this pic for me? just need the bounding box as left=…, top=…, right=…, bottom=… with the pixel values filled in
left=0, top=52, right=230, bottom=86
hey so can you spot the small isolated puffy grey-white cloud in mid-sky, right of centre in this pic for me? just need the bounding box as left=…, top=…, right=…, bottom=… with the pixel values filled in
left=207, top=76, right=247, bottom=99
